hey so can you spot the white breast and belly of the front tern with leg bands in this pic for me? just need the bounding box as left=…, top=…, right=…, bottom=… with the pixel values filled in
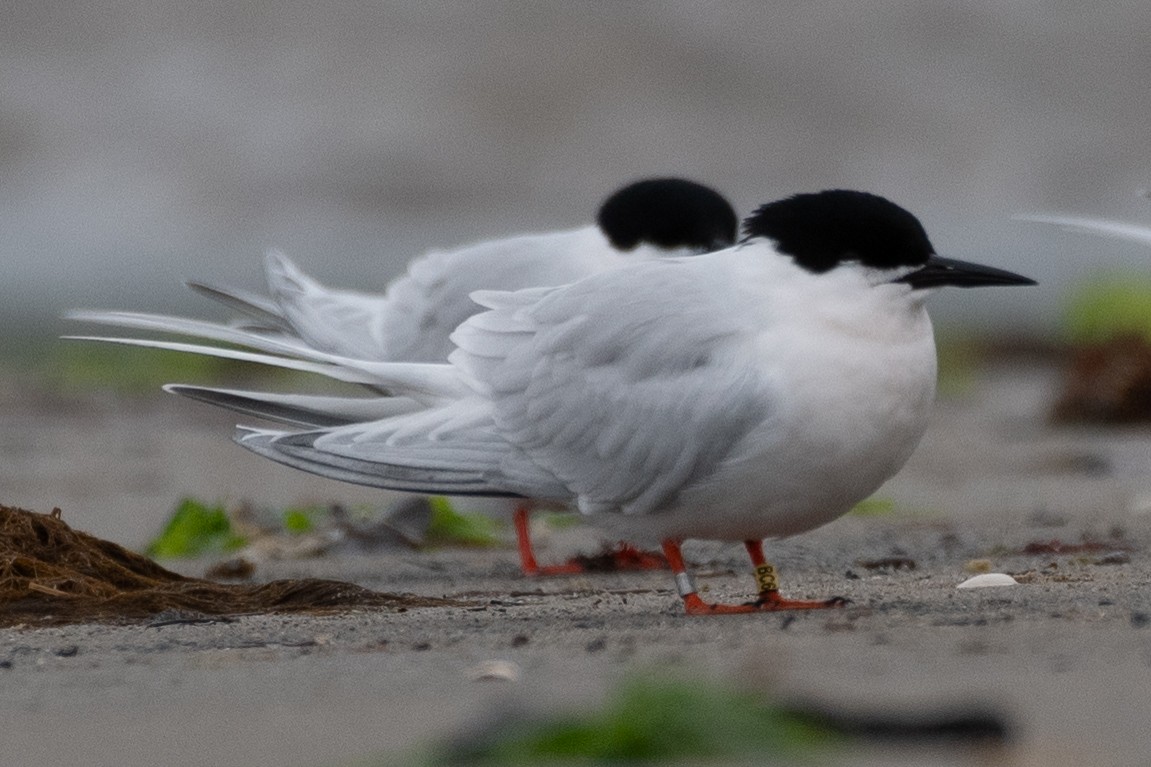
left=595, top=314, right=936, bottom=542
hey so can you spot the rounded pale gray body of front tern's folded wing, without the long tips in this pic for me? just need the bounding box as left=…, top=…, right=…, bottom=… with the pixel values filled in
left=452, top=257, right=769, bottom=514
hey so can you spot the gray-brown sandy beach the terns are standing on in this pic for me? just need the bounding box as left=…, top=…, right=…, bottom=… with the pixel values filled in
left=0, top=365, right=1151, bottom=767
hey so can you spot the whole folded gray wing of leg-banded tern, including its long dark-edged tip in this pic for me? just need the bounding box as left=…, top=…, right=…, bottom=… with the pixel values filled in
left=237, top=257, right=770, bottom=514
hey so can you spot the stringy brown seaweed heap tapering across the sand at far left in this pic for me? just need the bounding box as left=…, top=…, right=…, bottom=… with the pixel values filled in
left=0, top=506, right=464, bottom=626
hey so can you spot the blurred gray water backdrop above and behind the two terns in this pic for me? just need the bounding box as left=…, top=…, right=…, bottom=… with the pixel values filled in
left=0, top=0, right=1151, bottom=343
